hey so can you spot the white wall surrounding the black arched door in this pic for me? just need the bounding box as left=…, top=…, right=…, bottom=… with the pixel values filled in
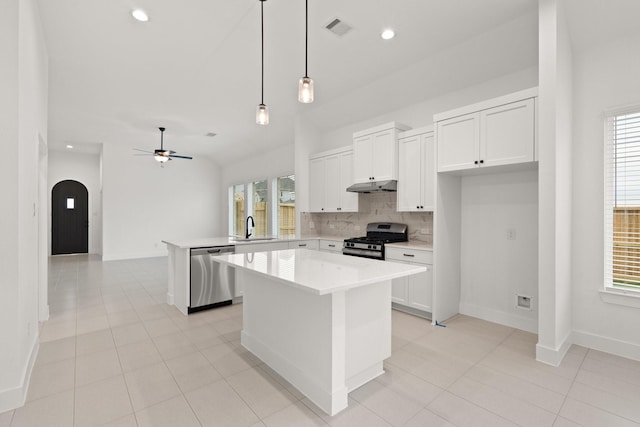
left=47, top=151, right=102, bottom=254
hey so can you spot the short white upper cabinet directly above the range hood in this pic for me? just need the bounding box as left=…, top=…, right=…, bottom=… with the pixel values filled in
left=352, top=122, right=409, bottom=184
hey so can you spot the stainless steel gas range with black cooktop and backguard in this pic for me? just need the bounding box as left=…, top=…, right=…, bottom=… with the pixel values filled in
left=342, top=222, right=409, bottom=259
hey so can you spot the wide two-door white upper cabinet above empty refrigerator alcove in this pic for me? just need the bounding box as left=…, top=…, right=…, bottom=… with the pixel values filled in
left=434, top=89, right=537, bottom=172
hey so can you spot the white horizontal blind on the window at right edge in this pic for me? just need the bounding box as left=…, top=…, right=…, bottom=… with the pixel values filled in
left=604, top=107, right=640, bottom=289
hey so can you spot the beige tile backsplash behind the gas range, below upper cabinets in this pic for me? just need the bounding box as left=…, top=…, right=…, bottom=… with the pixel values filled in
left=300, top=192, right=433, bottom=244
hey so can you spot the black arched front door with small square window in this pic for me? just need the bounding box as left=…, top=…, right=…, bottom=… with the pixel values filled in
left=51, top=180, right=89, bottom=255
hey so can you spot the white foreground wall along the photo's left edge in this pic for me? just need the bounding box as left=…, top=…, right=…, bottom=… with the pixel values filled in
left=0, top=0, right=47, bottom=412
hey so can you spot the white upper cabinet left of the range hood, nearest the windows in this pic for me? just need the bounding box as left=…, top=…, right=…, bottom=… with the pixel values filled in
left=309, top=147, right=358, bottom=212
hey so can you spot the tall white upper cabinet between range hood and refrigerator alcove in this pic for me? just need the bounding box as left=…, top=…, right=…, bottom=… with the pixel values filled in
left=397, top=126, right=436, bottom=212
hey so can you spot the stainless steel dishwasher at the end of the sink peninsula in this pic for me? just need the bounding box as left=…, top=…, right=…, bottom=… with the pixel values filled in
left=188, top=246, right=236, bottom=313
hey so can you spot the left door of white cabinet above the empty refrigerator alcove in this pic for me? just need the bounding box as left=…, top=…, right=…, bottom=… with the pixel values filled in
left=437, top=113, right=480, bottom=172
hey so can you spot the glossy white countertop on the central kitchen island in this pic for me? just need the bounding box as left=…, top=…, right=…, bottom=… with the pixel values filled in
left=213, top=249, right=427, bottom=295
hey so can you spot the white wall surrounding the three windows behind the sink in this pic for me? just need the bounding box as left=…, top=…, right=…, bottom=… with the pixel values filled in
left=219, top=144, right=300, bottom=236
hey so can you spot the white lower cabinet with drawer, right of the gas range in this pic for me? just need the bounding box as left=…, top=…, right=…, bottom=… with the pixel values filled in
left=385, top=246, right=433, bottom=314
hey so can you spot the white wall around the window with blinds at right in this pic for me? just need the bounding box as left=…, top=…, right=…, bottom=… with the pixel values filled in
left=572, top=34, right=640, bottom=360
